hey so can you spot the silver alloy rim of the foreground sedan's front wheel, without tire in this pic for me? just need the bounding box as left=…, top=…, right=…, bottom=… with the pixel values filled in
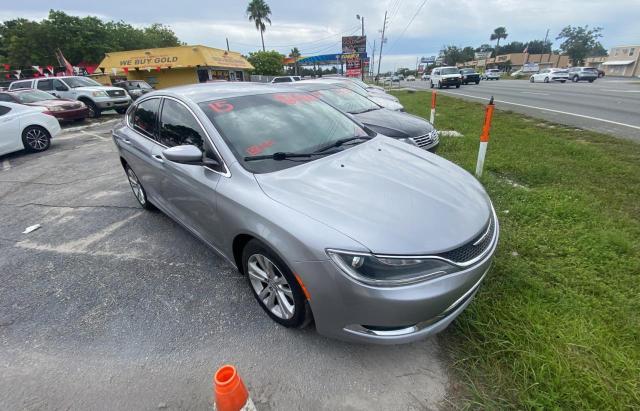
left=247, top=254, right=295, bottom=320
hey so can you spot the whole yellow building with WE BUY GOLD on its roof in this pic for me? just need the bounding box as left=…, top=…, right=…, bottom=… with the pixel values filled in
left=98, top=46, right=253, bottom=89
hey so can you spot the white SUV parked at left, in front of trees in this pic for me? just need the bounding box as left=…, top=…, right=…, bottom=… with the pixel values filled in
left=9, top=76, right=131, bottom=118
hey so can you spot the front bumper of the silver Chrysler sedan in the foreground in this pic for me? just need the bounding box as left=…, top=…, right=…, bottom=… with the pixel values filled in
left=293, top=219, right=499, bottom=344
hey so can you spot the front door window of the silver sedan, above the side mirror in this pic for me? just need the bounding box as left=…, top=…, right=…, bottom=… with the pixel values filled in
left=160, top=99, right=205, bottom=151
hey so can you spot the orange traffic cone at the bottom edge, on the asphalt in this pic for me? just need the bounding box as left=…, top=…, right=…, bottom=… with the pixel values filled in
left=213, top=365, right=256, bottom=411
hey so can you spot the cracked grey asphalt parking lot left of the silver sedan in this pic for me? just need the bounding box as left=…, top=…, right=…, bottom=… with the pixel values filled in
left=0, top=116, right=449, bottom=410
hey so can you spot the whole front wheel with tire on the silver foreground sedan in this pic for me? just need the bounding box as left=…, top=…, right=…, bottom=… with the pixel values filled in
left=242, top=240, right=312, bottom=328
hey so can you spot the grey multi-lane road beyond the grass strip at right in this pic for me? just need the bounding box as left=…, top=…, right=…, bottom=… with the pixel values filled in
left=401, top=77, right=640, bottom=142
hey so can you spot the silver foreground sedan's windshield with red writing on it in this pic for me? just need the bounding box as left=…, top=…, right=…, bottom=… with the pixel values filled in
left=200, top=93, right=368, bottom=173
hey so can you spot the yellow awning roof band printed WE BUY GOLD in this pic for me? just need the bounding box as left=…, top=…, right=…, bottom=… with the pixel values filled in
left=98, top=46, right=253, bottom=72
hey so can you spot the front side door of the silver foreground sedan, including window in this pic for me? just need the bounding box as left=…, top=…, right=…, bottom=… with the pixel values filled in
left=154, top=97, right=225, bottom=247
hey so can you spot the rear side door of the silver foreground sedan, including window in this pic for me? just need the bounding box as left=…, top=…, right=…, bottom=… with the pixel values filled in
left=113, top=97, right=164, bottom=207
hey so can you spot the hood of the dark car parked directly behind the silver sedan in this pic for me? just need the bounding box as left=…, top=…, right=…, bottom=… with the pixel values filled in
left=353, top=108, right=433, bottom=138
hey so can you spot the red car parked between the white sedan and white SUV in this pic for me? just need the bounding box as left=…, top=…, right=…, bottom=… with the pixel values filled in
left=0, top=88, right=89, bottom=121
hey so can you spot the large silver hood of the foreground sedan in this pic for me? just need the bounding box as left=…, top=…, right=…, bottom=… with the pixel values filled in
left=255, top=136, right=491, bottom=255
